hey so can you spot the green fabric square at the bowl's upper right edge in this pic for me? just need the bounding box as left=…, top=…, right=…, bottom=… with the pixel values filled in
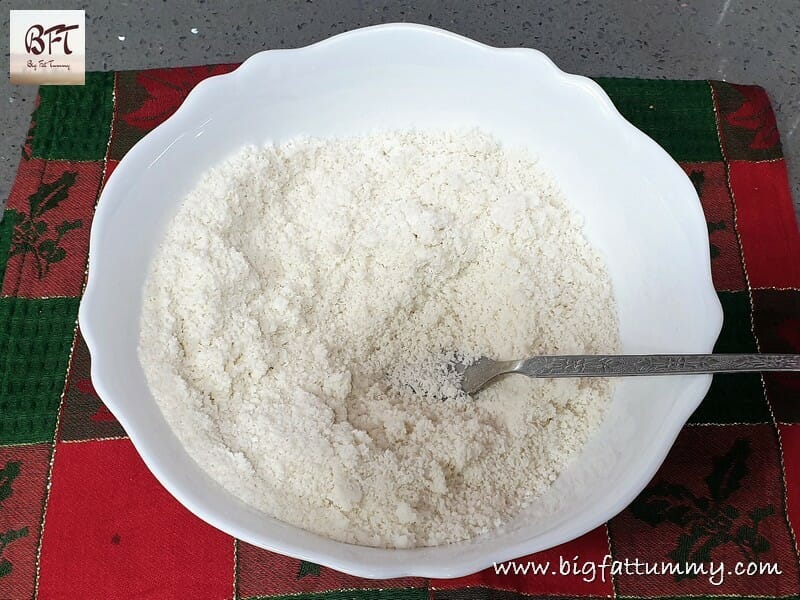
left=595, top=77, right=722, bottom=162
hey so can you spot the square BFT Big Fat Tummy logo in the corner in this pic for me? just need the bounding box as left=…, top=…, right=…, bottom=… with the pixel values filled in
left=10, top=10, right=86, bottom=85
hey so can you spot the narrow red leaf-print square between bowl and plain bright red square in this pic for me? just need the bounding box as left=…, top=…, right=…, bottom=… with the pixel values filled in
left=681, top=162, right=747, bottom=291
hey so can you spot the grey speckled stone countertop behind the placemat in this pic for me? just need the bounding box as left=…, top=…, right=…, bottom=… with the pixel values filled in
left=0, top=0, right=800, bottom=213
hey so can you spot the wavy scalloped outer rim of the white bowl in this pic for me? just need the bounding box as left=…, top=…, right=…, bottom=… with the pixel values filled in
left=79, top=24, right=722, bottom=578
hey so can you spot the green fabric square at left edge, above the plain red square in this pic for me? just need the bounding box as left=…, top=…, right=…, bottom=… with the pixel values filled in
left=0, top=296, right=79, bottom=444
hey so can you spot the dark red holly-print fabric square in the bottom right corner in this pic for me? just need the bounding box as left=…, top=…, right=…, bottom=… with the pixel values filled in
left=609, top=425, right=800, bottom=597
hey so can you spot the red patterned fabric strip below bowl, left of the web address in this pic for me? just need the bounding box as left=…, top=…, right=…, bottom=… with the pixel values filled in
left=236, top=541, right=425, bottom=598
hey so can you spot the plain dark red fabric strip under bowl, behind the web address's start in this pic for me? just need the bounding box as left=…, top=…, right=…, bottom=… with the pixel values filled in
left=430, top=526, right=614, bottom=597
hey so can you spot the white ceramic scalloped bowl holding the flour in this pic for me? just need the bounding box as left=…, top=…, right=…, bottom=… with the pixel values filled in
left=80, top=24, right=722, bottom=578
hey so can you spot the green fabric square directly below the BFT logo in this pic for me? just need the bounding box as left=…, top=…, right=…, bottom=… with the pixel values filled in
left=31, top=72, right=114, bottom=160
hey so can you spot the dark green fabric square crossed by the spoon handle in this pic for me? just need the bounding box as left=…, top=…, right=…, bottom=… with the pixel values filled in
left=689, top=292, right=770, bottom=423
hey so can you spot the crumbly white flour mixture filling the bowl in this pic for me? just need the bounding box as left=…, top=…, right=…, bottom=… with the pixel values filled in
left=140, top=132, right=619, bottom=547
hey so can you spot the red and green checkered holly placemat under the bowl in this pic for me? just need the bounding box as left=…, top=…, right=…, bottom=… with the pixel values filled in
left=0, top=65, right=800, bottom=600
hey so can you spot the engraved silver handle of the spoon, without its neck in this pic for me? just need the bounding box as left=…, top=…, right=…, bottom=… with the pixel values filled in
left=513, top=354, right=800, bottom=377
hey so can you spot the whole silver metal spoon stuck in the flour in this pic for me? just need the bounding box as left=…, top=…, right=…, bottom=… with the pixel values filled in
left=454, top=354, right=800, bottom=394
